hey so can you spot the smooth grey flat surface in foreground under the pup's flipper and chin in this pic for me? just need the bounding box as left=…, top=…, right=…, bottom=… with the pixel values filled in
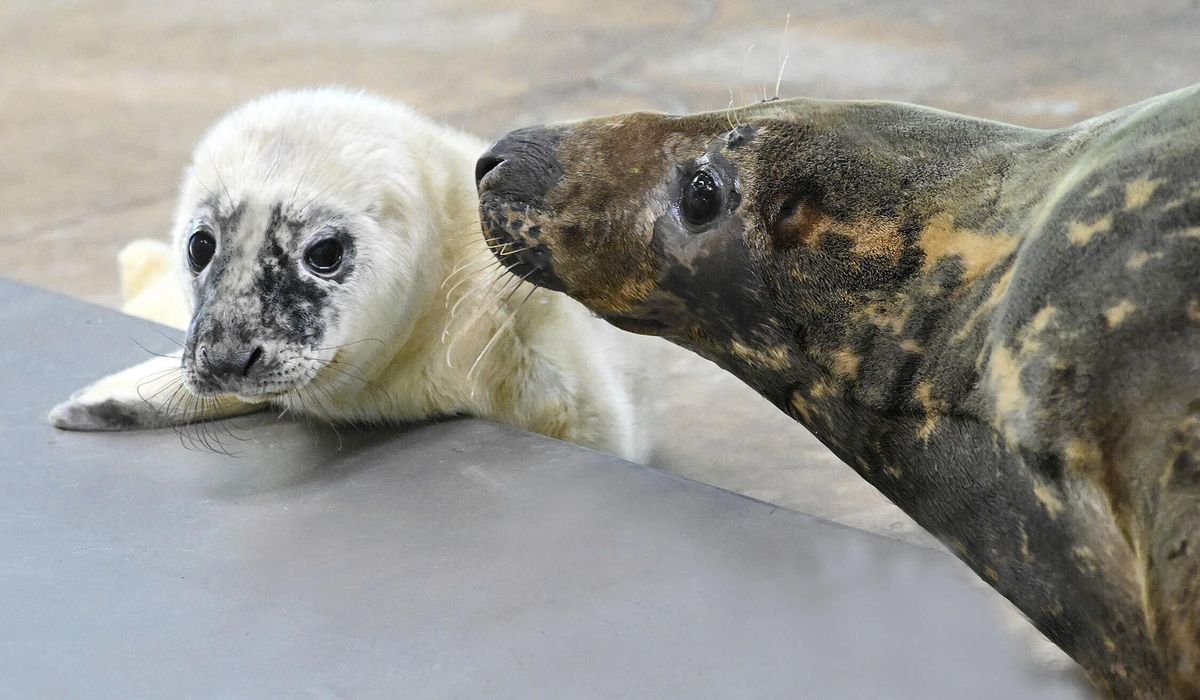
left=0, top=281, right=1081, bottom=699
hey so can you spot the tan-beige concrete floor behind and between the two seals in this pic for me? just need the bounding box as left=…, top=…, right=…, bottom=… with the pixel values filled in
left=0, top=0, right=1200, bottom=681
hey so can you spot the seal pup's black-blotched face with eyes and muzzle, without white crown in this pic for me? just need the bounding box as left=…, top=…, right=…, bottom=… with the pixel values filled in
left=180, top=192, right=355, bottom=400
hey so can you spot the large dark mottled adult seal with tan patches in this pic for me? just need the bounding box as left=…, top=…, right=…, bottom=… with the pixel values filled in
left=478, top=88, right=1200, bottom=696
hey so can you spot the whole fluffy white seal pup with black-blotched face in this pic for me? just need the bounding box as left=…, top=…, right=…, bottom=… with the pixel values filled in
left=49, top=89, right=641, bottom=460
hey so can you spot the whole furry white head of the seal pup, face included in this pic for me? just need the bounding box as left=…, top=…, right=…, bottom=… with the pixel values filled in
left=174, top=91, right=444, bottom=409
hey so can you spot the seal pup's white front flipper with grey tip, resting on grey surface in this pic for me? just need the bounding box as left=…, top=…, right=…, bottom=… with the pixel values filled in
left=49, top=353, right=266, bottom=431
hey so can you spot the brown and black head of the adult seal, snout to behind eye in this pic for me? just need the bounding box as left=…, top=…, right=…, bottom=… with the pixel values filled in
left=476, top=114, right=762, bottom=348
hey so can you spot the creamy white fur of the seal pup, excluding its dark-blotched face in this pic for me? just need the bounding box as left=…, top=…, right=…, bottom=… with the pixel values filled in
left=50, top=89, right=641, bottom=459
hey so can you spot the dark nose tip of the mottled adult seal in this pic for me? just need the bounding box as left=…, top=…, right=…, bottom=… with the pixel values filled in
left=475, top=126, right=563, bottom=196
